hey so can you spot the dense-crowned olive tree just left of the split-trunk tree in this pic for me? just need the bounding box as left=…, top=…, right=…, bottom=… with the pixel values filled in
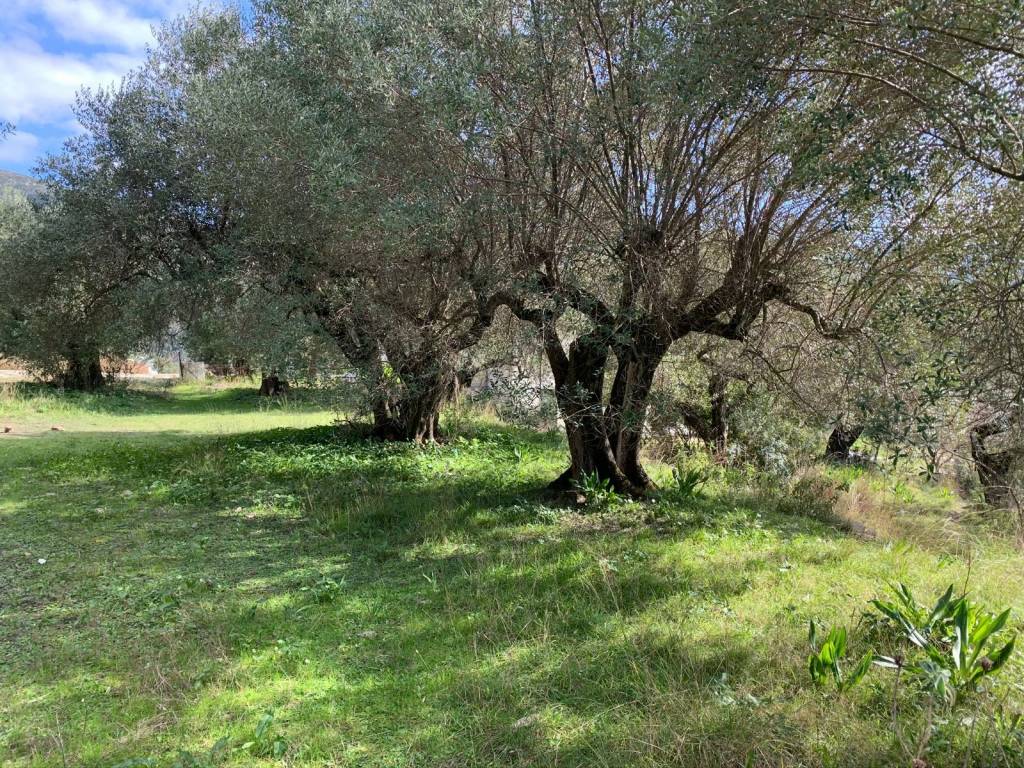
left=166, top=2, right=516, bottom=440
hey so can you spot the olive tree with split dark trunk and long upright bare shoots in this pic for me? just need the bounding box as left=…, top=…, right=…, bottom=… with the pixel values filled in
left=438, top=2, right=947, bottom=490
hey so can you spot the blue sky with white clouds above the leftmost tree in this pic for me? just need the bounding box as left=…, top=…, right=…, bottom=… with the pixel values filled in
left=0, top=0, right=208, bottom=173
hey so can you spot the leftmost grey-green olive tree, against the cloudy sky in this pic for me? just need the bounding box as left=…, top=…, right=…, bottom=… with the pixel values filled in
left=0, top=13, right=247, bottom=389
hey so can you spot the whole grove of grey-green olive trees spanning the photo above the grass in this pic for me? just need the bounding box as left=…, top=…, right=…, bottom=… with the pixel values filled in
left=0, top=0, right=1024, bottom=500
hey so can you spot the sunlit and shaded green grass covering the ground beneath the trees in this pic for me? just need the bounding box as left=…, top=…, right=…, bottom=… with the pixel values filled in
left=0, top=387, right=1024, bottom=768
